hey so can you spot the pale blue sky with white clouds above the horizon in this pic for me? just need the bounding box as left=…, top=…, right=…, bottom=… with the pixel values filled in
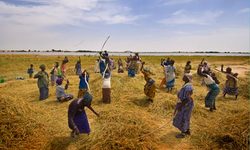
left=0, top=0, right=250, bottom=52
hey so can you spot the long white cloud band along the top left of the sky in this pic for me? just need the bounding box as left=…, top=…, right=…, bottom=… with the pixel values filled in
left=0, top=0, right=139, bottom=27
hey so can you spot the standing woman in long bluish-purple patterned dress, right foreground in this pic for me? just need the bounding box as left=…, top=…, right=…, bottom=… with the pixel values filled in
left=173, top=74, right=194, bottom=138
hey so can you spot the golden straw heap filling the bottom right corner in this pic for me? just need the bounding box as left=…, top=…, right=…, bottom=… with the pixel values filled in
left=193, top=111, right=250, bottom=150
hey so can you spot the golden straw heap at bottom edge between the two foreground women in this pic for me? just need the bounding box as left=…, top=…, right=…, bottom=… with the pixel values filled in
left=78, top=109, right=160, bottom=150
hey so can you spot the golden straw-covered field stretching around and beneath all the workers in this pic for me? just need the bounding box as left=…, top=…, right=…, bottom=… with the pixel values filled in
left=0, top=55, right=250, bottom=150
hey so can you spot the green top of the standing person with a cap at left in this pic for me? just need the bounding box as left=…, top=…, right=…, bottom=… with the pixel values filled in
left=34, top=71, right=49, bottom=88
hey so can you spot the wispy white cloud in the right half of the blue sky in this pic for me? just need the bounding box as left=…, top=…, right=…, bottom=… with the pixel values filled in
left=159, top=10, right=223, bottom=25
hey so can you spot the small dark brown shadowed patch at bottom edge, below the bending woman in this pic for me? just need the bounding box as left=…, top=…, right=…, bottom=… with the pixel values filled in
left=46, top=137, right=74, bottom=150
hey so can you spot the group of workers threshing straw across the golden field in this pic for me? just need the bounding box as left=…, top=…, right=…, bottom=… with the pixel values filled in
left=27, top=51, right=238, bottom=138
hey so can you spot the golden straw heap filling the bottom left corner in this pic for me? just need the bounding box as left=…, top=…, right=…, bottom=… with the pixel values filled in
left=0, top=97, right=46, bottom=149
